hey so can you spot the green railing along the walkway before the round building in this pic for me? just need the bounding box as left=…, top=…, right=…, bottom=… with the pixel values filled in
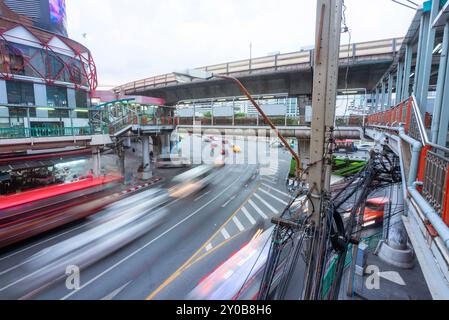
left=0, top=127, right=101, bottom=139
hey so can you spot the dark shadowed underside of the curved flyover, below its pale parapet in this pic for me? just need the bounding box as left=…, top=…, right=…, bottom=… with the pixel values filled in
left=126, top=59, right=392, bottom=105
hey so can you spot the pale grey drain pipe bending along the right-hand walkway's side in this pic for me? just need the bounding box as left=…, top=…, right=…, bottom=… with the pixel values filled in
left=399, top=128, right=449, bottom=249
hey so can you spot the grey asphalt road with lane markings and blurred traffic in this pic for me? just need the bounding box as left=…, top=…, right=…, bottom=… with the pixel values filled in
left=0, top=137, right=291, bottom=300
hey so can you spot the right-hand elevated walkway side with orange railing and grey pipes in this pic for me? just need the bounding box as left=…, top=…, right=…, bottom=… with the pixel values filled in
left=364, top=96, right=449, bottom=299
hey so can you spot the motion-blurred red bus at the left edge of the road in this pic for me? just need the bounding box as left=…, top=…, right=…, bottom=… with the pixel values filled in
left=0, top=176, right=123, bottom=248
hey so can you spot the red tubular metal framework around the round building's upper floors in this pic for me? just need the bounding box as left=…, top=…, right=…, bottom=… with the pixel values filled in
left=0, top=1, right=98, bottom=95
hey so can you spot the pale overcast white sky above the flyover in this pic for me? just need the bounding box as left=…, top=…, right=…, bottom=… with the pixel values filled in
left=66, top=0, right=416, bottom=86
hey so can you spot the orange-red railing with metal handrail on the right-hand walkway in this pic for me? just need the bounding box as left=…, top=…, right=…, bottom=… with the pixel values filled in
left=366, top=97, right=449, bottom=226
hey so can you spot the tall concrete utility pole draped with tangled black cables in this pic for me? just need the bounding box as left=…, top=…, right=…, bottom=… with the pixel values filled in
left=303, top=0, right=343, bottom=300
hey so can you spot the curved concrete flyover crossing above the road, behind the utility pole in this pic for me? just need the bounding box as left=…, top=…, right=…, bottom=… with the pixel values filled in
left=114, top=38, right=404, bottom=105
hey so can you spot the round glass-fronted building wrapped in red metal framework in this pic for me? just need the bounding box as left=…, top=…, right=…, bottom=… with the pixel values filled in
left=0, top=0, right=97, bottom=129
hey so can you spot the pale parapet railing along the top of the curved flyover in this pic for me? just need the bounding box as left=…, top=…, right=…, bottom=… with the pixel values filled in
left=116, top=38, right=403, bottom=93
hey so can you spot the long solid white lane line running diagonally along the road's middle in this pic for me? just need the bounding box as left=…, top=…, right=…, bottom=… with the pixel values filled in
left=57, top=172, right=248, bottom=300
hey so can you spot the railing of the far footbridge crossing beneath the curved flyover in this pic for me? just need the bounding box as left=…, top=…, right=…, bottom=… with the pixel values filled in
left=176, top=116, right=363, bottom=127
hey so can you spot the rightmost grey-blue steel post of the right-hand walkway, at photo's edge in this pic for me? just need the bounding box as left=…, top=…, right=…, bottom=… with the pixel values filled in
left=431, top=22, right=449, bottom=143
